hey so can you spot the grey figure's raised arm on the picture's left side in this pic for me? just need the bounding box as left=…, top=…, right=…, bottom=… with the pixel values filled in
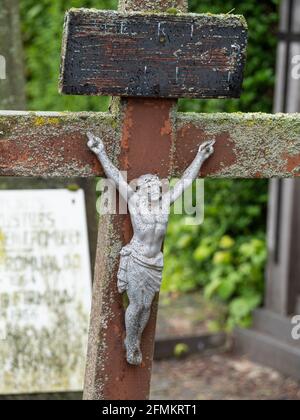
left=87, top=133, right=133, bottom=201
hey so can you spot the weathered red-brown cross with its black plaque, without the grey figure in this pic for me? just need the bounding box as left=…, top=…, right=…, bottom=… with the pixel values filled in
left=0, top=0, right=300, bottom=399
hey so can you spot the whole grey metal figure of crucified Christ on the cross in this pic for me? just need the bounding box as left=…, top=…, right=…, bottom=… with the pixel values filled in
left=87, top=133, right=215, bottom=366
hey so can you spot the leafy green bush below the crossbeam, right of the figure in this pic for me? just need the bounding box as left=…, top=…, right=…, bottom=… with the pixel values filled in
left=162, top=180, right=268, bottom=328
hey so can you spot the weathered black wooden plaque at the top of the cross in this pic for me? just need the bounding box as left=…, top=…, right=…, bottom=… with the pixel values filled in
left=60, top=9, right=247, bottom=98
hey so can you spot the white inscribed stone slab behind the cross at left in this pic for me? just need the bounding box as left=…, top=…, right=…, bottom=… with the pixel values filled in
left=0, top=190, right=91, bottom=394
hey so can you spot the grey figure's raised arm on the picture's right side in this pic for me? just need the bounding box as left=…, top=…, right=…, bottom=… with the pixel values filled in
left=167, top=140, right=215, bottom=204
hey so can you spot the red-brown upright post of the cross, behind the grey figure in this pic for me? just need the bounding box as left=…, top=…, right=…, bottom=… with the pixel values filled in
left=84, top=0, right=187, bottom=400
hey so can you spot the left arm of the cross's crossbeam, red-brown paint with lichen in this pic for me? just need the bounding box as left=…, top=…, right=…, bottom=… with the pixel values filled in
left=0, top=112, right=119, bottom=177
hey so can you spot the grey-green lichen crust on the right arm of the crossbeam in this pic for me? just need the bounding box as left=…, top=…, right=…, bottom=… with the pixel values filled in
left=178, top=113, right=300, bottom=178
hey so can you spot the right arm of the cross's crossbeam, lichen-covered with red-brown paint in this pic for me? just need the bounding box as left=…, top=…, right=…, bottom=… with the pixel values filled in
left=177, top=113, right=300, bottom=178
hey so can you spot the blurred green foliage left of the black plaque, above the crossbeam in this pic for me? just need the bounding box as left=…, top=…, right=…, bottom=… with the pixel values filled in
left=20, top=0, right=118, bottom=111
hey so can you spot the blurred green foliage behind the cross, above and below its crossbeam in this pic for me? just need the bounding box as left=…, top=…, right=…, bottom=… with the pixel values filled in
left=20, top=0, right=279, bottom=328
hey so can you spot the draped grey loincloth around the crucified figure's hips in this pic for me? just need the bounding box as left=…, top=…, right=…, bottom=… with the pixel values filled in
left=118, top=245, right=164, bottom=293
